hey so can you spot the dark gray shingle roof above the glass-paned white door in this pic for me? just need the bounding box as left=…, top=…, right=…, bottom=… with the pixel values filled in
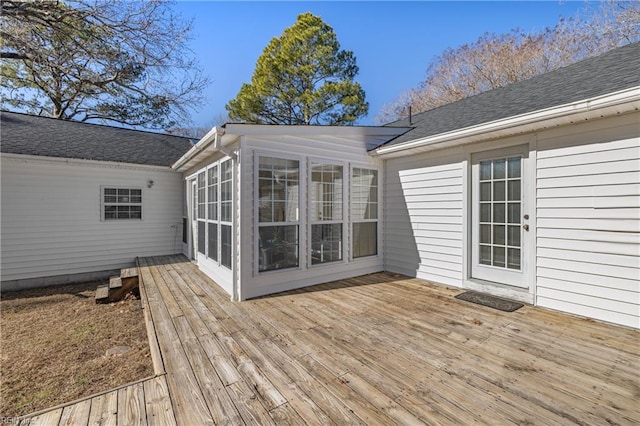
left=385, top=43, right=640, bottom=146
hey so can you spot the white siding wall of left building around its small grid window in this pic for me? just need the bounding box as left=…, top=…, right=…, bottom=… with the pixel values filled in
left=1, top=155, right=183, bottom=289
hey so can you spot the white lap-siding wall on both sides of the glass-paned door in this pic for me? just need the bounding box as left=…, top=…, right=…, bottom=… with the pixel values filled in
left=384, top=113, right=640, bottom=328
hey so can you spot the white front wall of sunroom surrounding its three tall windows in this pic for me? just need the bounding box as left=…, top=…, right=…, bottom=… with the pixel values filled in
left=239, top=131, right=383, bottom=299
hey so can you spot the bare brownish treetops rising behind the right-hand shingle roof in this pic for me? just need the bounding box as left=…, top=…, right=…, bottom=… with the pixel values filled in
left=376, top=1, right=640, bottom=123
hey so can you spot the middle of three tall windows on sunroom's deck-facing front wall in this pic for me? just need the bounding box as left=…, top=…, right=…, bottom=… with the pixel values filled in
left=310, top=163, right=344, bottom=265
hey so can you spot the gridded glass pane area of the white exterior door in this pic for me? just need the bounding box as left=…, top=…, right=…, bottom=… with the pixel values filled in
left=478, top=157, right=522, bottom=270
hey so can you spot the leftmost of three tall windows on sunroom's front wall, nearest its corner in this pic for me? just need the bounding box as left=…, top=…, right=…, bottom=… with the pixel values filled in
left=257, top=156, right=300, bottom=272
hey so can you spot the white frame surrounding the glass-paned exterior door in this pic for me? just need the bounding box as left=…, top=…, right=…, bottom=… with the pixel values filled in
left=462, top=134, right=537, bottom=304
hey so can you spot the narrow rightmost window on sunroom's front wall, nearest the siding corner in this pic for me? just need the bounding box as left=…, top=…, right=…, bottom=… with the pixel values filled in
left=351, top=167, right=378, bottom=258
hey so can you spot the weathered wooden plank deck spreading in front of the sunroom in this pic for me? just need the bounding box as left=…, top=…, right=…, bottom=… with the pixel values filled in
left=20, top=256, right=640, bottom=425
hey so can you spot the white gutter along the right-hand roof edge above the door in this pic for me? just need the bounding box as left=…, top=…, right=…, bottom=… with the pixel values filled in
left=373, top=86, right=640, bottom=156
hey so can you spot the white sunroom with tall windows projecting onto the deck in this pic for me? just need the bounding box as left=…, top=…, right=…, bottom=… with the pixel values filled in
left=173, top=124, right=408, bottom=300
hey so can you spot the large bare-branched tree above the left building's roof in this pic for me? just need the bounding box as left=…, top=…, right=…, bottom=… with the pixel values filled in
left=0, top=0, right=208, bottom=128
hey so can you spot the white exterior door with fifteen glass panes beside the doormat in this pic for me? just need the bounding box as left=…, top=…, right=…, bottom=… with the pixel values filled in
left=471, top=146, right=529, bottom=288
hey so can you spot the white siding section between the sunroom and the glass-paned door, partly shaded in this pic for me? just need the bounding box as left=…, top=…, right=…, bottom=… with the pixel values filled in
left=384, top=150, right=464, bottom=286
